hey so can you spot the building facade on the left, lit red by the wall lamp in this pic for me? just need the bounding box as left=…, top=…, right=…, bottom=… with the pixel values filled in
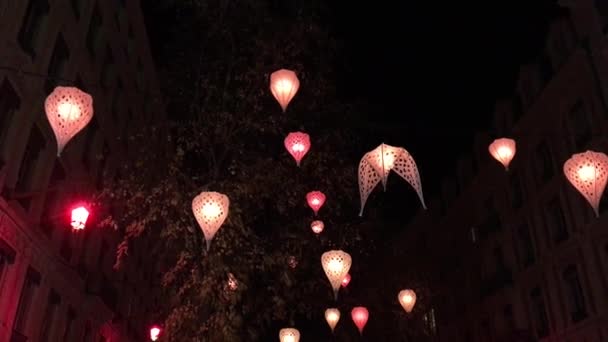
left=0, top=0, right=164, bottom=342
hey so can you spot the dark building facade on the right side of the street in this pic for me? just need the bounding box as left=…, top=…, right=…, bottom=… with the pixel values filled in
left=395, top=0, right=608, bottom=342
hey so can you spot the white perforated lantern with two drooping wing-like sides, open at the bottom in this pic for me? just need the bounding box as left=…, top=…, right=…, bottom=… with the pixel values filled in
left=359, top=144, right=426, bottom=216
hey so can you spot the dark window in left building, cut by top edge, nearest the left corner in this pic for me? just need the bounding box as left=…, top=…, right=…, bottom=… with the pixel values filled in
left=18, top=0, right=49, bottom=57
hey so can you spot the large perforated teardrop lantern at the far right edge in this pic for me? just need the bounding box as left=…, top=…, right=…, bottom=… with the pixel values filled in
left=564, top=151, right=608, bottom=217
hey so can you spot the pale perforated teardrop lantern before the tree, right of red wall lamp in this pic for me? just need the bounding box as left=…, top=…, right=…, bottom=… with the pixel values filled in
left=192, top=191, right=230, bottom=250
